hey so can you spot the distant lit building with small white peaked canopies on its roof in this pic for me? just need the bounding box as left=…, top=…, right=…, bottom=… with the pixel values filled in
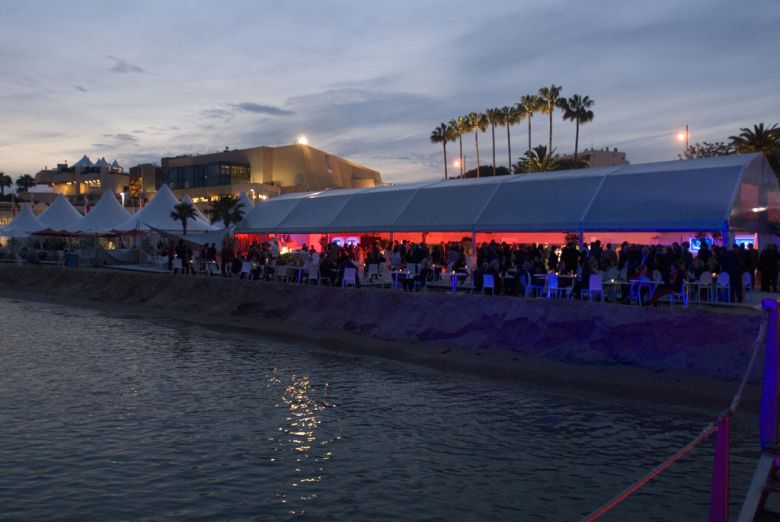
left=32, top=154, right=130, bottom=205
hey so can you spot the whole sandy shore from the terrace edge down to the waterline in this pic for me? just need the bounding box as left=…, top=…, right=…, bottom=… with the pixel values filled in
left=0, top=266, right=760, bottom=409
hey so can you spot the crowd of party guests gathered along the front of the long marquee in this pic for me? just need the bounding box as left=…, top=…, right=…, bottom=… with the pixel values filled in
left=158, top=234, right=780, bottom=304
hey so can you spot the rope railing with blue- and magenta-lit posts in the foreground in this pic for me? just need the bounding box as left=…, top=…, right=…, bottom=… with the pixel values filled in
left=583, top=299, right=780, bottom=522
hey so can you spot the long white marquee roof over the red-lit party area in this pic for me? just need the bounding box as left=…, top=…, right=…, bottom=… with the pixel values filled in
left=238, top=154, right=780, bottom=233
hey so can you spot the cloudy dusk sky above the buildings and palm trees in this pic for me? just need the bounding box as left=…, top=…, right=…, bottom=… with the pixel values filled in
left=0, top=0, right=780, bottom=183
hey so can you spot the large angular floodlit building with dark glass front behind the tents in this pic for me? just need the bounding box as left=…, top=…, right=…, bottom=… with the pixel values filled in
left=161, top=144, right=382, bottom=202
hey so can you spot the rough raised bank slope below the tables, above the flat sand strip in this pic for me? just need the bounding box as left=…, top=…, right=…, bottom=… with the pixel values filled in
left=0, top=265, right=760, bottom=379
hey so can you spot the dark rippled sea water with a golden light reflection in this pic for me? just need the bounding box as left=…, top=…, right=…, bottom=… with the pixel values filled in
left=0, top=299, right=756, bottom=520
